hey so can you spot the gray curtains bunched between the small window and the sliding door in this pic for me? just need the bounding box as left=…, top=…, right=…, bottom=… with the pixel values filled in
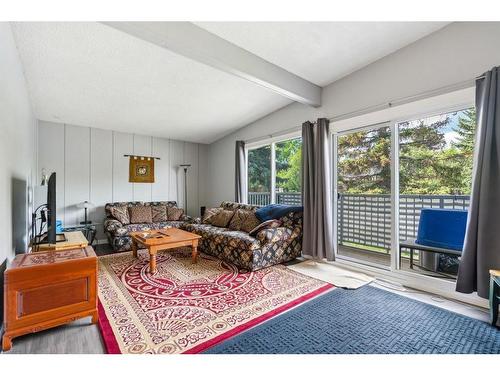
left=302, top=118, right=335, bottom=260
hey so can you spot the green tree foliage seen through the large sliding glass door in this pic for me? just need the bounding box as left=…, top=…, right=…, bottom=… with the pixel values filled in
left=338, top=109, right=476, bottom=195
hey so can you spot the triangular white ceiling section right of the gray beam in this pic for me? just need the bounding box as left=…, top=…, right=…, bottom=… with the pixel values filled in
left=196, top=22, right=448, bottom=87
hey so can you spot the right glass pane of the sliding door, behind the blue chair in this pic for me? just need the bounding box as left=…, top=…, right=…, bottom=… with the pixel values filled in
left=397, top=108, right=476, bottom=278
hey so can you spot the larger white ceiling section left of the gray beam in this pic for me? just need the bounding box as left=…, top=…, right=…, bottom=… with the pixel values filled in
left=8, top=23, right=291, bottom=143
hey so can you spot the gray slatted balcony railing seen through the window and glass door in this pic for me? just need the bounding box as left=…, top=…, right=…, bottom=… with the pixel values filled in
left=248, top=192, right=470, bottom=253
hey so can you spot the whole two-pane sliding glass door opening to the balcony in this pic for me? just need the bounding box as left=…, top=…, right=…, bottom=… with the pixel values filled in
left=333, top=108, right=476, bottom=279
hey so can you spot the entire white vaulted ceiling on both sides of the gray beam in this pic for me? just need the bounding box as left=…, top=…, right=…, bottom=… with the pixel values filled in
left=12, top=22, right=450, bottom=143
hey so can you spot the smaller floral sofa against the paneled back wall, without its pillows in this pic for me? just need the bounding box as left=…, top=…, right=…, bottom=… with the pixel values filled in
left=104, top=201, right=191, bottom=251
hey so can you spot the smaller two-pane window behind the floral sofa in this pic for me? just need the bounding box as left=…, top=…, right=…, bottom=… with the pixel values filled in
left=247, top=138, right=302, bottom=206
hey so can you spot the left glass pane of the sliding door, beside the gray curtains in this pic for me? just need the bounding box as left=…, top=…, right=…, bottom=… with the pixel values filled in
left=335, top=124, right=392, bottom=267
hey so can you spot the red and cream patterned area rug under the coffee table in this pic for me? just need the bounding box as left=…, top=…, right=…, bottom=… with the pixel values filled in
left=99, top=249, right=334, bottom=354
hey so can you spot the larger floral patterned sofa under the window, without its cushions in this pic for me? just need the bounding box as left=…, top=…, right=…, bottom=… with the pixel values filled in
left=181, top=202, right=302, bottom=271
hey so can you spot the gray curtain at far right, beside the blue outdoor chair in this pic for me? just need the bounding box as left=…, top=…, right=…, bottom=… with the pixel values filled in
left=457, top=68, right=500, bottom=298
